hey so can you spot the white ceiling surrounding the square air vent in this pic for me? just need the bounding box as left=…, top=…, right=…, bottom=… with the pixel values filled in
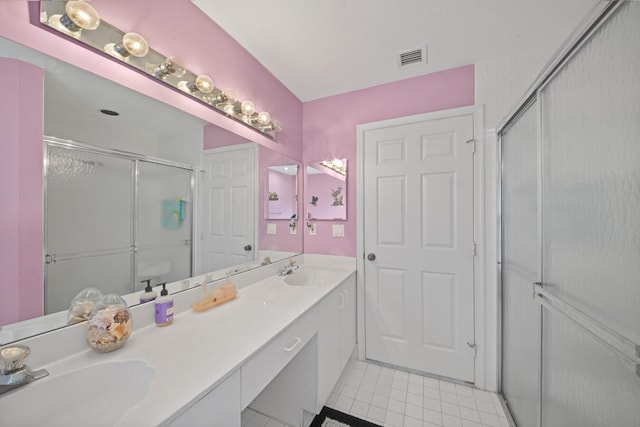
left=193, top=0, right=595, bottom=101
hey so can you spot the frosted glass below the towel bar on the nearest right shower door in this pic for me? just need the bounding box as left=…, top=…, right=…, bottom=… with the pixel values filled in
left=542, top=311, right=640, bottom=427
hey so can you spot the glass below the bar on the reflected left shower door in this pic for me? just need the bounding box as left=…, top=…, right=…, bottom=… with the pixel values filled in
left=45, top=253, right=133, bottom=314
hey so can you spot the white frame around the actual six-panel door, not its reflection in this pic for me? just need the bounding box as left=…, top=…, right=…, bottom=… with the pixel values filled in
left=356, top=104, right=484, bottom=389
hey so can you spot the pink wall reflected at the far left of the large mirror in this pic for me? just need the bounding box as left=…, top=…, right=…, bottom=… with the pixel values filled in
left=0, top=58, right=44, bottom=325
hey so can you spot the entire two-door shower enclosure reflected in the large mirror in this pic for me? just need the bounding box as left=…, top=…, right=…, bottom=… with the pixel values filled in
left=44, top=137, right=194, bottom=314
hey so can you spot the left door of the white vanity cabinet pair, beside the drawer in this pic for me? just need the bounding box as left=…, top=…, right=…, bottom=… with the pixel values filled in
left=316, top=287, right=343, bottom=411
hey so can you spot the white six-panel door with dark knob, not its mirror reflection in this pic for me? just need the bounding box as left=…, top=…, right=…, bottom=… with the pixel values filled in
left=363, top=113, right=475, bottom=382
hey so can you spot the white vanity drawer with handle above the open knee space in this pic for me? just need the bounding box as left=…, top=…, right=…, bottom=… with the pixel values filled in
left=240, top=307, right=318, bottom=410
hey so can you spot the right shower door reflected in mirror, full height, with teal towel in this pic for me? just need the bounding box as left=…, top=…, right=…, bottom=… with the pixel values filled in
left=136, top=161, right=192, bottom=289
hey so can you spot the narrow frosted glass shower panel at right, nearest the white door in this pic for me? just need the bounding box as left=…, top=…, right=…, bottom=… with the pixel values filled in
left=502, top=103, right=540, bottom=426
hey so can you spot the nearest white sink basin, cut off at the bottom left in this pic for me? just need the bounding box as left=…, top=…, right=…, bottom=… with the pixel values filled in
left=0, top=360, right=155, bottom=427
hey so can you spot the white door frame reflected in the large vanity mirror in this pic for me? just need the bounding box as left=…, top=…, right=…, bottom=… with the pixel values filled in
left=199, top=142, right=260, bottom=274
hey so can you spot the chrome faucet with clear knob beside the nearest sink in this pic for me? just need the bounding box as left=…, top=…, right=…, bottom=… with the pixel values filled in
left=0, top=345, right=49, bottom=394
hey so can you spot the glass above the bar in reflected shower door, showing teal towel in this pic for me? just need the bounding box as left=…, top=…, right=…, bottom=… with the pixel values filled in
left=138, top=161, right=192, bottom=245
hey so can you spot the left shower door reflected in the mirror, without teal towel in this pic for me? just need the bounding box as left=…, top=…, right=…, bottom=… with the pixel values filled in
left=45, top=144, right=133, bottom=314
